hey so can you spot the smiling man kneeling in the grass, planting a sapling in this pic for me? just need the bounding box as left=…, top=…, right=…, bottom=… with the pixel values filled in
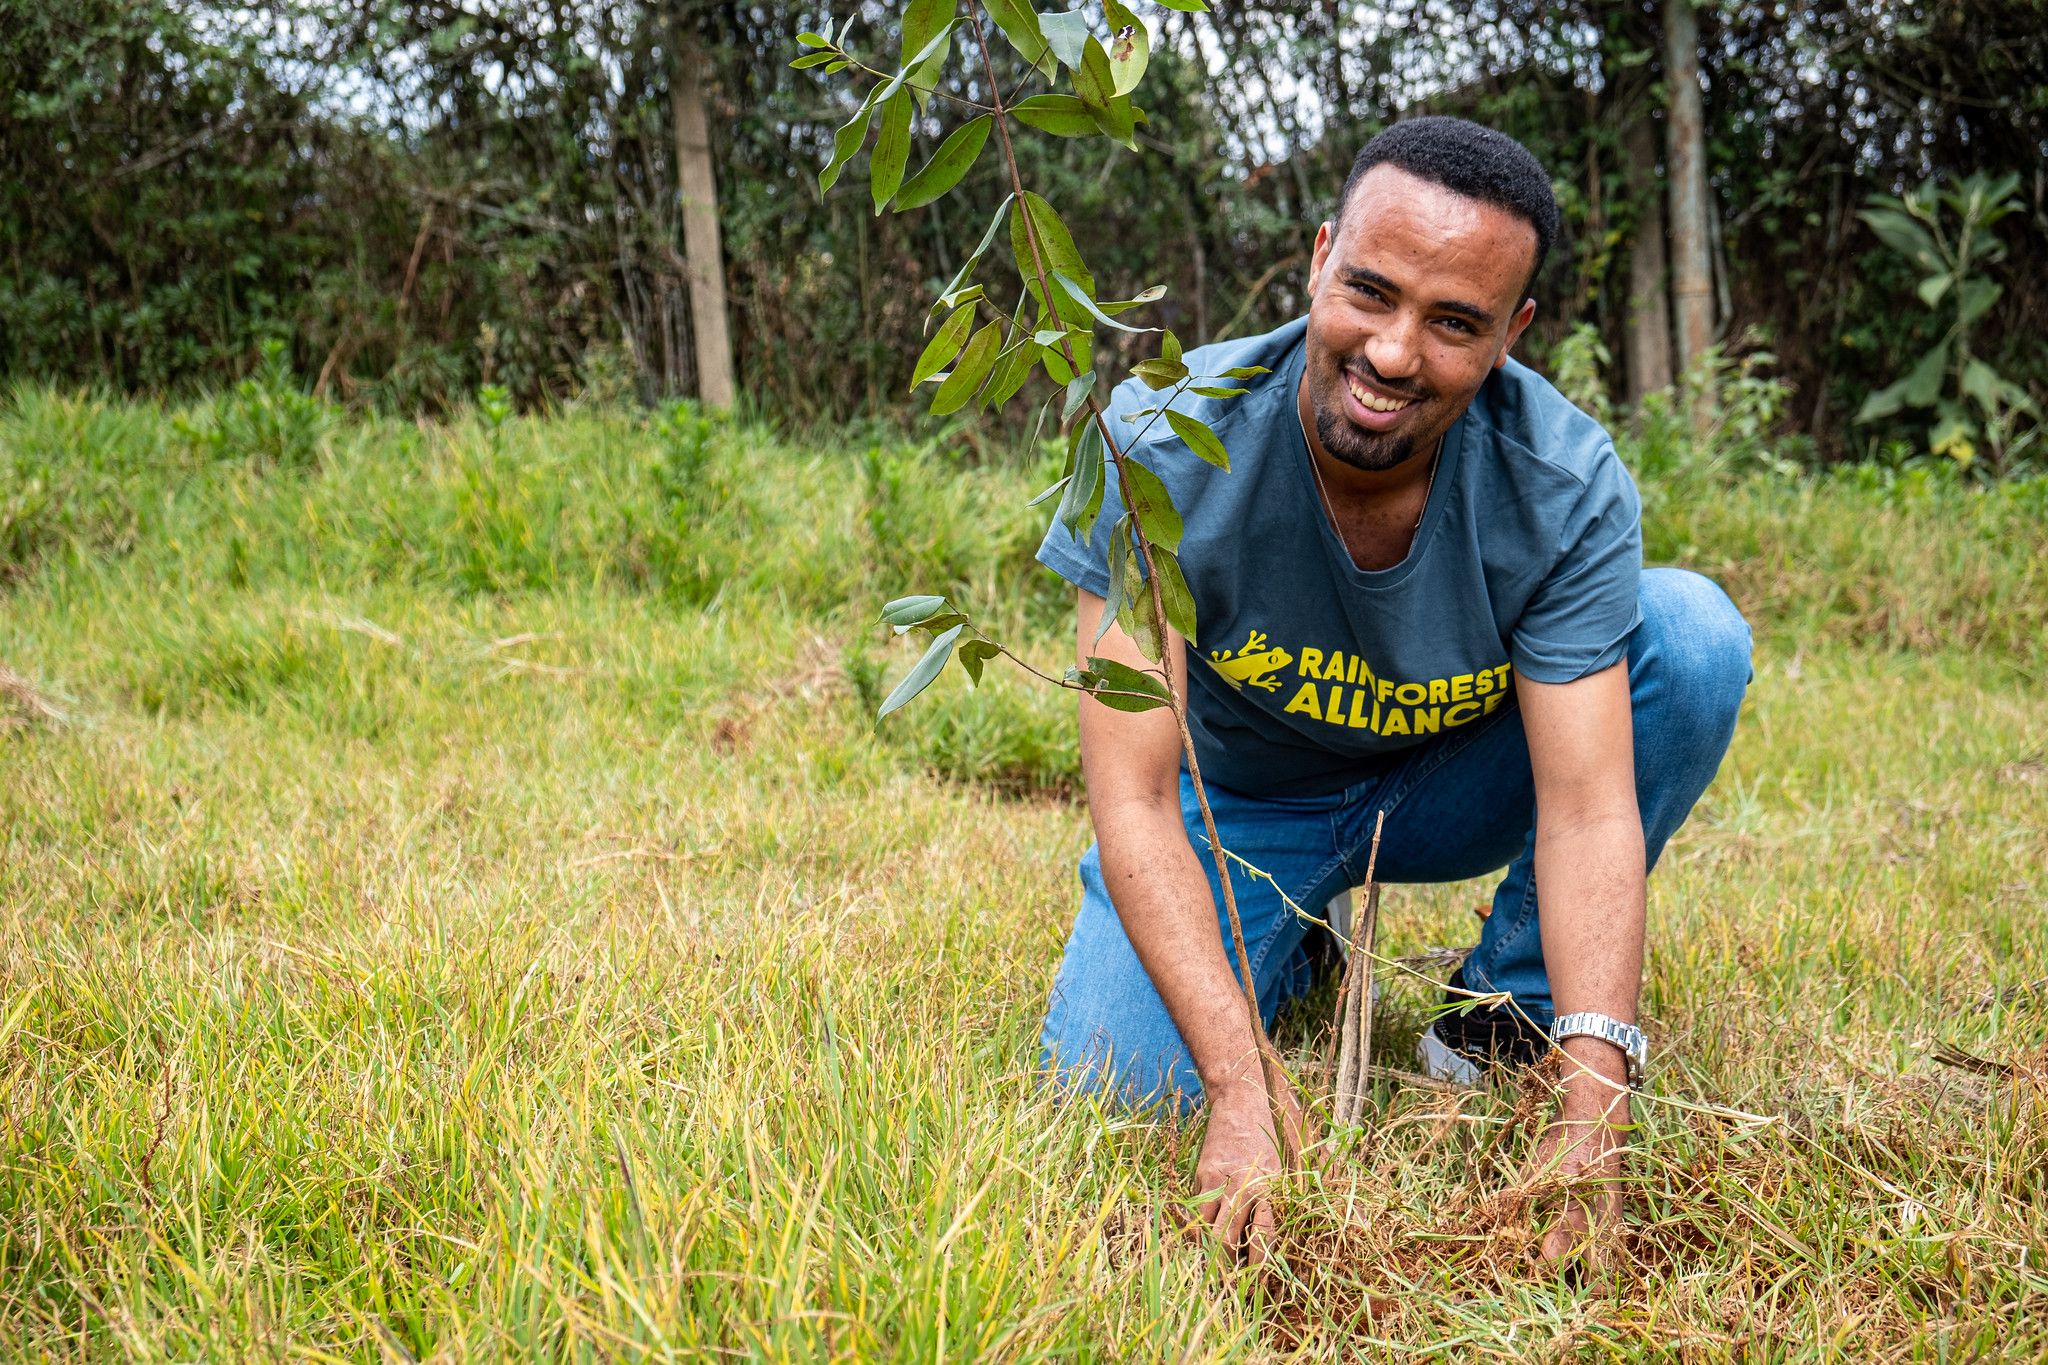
left=1038, top=119, right=1749, bottom=1254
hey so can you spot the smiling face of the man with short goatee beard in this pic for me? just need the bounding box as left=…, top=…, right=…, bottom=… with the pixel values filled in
left=1305, top=166, right=1536, bottom=471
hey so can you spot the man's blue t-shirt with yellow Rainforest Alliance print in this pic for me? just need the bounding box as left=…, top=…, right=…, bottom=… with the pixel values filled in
left=1038, top=319, right=1642, bottom=796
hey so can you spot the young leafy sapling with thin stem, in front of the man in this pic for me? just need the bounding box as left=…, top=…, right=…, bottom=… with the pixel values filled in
left=793, top=0, right=1298, bottom=1162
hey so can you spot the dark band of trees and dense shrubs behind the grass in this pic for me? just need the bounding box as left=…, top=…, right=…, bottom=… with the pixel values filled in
left=12, top=0, right=2048, bottom=463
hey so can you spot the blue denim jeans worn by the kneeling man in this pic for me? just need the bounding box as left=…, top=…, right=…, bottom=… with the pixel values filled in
left=1040, top=569, right=1751, bottom=1107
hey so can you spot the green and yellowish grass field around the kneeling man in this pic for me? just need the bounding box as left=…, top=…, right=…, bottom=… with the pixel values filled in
left=0, top=391, right=2048, bottom=1361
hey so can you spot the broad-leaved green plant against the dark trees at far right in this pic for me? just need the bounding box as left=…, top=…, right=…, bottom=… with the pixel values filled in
left=1855, top=174, right=2040, bottom=473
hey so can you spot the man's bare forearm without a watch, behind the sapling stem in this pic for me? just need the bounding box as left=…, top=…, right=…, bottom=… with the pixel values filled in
left=1096, top=802, right=1260, bottom=1101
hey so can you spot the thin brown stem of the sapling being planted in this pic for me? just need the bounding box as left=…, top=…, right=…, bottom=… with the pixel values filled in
left=967, top=4, right=1300, bottom=1171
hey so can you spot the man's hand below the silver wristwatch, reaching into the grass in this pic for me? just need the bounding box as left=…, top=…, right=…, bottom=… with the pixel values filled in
left=1528, top=1038, right=1628, bottom=1261
